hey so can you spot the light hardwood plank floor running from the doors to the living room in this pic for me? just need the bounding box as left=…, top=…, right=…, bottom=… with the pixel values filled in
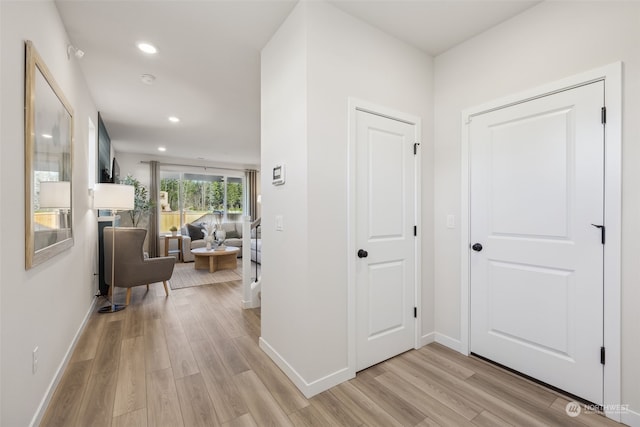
left=41, top=282, right=619, bottom=427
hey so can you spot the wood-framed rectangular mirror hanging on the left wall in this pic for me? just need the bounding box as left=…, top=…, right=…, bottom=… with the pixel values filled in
left=24, top=41, right=73, bottom=269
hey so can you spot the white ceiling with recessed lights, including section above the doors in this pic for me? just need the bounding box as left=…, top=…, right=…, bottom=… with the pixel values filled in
left=55, top=0, right=539, bottom=168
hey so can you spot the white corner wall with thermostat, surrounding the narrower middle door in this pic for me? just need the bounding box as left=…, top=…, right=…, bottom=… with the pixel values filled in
left=262, top=2, right=433, bottom=394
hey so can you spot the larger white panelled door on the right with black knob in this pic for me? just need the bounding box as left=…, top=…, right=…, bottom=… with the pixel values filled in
left=470, top=81, right=604, bottom=403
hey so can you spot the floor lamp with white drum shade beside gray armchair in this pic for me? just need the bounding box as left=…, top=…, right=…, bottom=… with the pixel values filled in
left=93, top=184, right=134, bottom=313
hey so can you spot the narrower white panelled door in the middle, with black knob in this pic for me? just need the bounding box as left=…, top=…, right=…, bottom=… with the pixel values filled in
left=353, top=111, right=416, bottom=370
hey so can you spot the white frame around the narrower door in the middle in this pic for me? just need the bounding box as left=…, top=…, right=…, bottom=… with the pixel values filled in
left=347, top=97, right=422, bottom=376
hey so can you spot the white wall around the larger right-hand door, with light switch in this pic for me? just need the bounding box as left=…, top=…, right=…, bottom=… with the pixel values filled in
left=435, top=1, right=640, bottom=425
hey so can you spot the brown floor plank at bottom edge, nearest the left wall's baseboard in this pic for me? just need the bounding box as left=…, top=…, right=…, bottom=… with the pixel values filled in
left=40, top=360, right=93, bottom=427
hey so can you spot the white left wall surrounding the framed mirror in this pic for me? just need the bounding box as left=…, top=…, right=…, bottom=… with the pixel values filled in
left=0, top=1, right=97, bottom=426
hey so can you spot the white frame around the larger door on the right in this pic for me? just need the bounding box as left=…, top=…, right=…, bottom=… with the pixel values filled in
left=459, top=62, right=622, bottom=421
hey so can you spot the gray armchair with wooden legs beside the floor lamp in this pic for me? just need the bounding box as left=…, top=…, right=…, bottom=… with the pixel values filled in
left=104, top=227, right=176, bottom=305
